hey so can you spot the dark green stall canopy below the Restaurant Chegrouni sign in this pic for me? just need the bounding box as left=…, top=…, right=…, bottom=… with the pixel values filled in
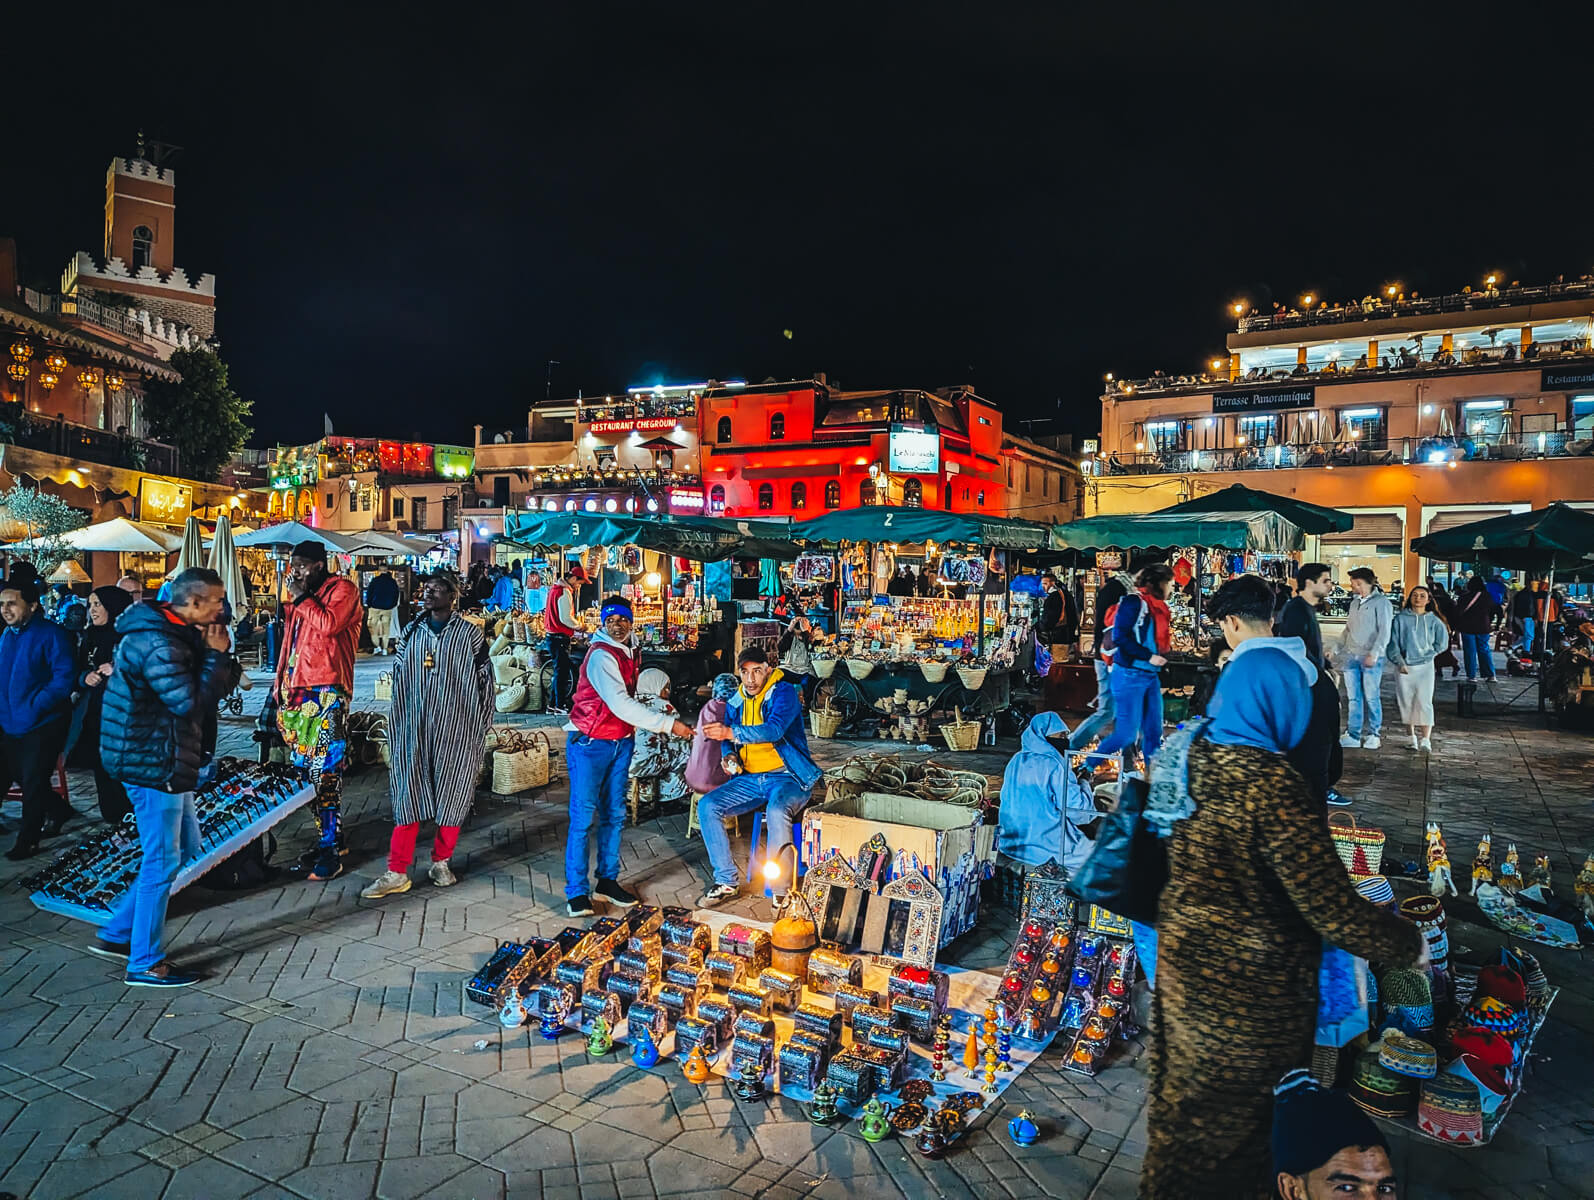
left=504, top=512, right=802, bottom=563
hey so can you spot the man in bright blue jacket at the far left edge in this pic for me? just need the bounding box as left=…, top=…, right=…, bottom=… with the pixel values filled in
left=0, top=577, right=77, bottom=861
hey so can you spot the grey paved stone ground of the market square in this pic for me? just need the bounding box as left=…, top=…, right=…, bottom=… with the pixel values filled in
left=0, top=660, right=1594, bottom=1200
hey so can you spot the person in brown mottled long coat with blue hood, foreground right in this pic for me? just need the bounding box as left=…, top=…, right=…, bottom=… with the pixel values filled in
left=1140, top=575, right=1427, bottom=1200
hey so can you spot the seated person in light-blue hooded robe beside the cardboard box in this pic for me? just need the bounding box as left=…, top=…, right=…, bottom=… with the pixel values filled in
left=996, top=712, right=1100, bottom=875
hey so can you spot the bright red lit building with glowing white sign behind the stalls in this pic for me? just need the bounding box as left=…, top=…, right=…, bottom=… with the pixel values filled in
left=698, top=376, right=1007, bottom=518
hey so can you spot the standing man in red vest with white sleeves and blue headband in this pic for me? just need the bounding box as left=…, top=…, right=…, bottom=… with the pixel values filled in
left=561, top=596, right=692, bottom=916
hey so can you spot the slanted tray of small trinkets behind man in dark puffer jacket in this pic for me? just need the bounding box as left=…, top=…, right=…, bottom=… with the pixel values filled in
left=22, top=757, right=314, bottom=924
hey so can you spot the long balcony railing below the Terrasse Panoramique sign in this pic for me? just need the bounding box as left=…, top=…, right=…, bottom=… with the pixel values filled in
left=1097, top=430, right=1594, bottom=475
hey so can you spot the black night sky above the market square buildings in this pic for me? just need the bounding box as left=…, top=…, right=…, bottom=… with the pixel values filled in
left=12, top=3, right=1594, bottom=445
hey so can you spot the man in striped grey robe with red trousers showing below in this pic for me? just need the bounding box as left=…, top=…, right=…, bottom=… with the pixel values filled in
left=360, top=571, right=493, bottom=900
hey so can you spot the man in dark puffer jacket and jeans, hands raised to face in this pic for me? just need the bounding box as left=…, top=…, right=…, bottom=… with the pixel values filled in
left=89, top=567, right=239, bottom=988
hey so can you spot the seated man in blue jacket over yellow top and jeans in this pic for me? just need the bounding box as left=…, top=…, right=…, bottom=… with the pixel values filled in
left=698, top=647, right=823, bottom=908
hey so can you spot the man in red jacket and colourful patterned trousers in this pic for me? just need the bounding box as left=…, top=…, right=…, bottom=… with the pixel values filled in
left=273, top=542, right=365, bottom=881
